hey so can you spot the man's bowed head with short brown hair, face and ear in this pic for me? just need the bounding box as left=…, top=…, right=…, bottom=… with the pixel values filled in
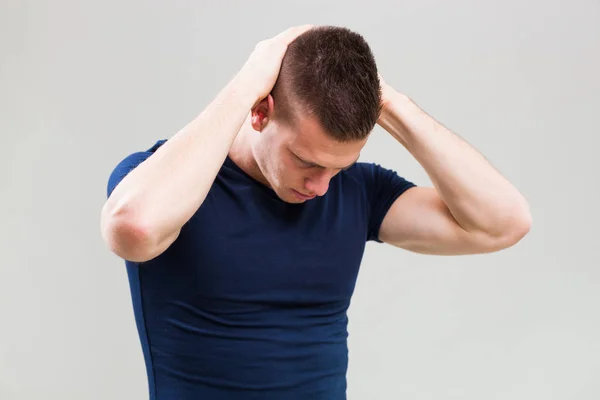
left=250, top=27, right=381, bottom=203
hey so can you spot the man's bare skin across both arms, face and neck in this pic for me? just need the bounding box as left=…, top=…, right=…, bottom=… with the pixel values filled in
left=100, top=25, right=531, bottom=262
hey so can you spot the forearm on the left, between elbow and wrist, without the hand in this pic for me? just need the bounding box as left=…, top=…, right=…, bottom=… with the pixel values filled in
left=102, top=74, right=255, bottom=253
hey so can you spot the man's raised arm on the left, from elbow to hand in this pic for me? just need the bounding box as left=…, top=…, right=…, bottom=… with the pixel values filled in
left=101, top=26, right=310, bottom=262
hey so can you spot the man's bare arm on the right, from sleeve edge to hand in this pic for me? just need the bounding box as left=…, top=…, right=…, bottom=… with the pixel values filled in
left=378, top=80, right=531, bottom=255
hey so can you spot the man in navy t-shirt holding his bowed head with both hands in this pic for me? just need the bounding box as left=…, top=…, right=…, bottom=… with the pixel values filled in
left=101, top=26, right=531, bottom=400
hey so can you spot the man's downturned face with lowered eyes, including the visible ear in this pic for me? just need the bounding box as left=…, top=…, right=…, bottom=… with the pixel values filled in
left=252, top=101, right=367, bottom=203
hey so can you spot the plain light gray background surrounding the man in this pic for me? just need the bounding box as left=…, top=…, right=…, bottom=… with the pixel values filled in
left=0, top=0, right=600, bottom=400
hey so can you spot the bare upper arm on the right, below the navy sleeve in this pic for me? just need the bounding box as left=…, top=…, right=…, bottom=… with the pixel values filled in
left=379, top=187, right=499, bottom=255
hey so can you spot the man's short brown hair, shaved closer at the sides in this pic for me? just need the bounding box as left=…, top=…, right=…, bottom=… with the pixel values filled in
left=271, top=26, right=381, bottom=142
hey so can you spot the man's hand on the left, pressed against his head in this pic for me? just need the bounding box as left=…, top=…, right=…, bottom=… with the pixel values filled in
left=239, top=25, right=313, bottom=105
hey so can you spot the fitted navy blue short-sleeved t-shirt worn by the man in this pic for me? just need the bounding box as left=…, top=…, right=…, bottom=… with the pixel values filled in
left=107, top=140, right=414, bottom=400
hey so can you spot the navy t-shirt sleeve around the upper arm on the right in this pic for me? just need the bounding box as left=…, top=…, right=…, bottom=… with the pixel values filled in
left=363, top=164, right=416, bottom=243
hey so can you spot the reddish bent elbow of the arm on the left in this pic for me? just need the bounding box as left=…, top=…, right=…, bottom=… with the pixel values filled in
left=101, top=203, right=158, bottom=262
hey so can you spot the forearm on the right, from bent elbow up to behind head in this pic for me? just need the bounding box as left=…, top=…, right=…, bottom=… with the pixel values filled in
left=379, top=88, right=530, bottom=236
